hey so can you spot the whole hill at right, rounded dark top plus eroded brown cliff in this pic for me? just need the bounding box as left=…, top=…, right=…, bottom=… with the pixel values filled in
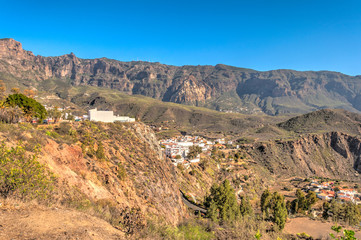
left=243, top=109, right=361, bottom=181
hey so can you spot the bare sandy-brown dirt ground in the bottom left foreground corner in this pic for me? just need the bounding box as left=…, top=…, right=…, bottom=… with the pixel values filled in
left=0, top=206, right=125, bottom=240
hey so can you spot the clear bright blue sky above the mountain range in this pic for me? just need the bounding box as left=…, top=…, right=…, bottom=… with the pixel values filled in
left=0, top=0, right=361, bottom=75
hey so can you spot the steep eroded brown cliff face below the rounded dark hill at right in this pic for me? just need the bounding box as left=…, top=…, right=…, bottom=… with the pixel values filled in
left=248, top=132, right=361, bottom=181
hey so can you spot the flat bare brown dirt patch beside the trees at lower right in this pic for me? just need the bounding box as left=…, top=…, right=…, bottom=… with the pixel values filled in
left=284, top=217, right=361, bottom=239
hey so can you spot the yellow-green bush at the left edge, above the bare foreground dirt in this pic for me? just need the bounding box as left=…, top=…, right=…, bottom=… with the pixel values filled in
left=0, top=144, right=55, bottom=200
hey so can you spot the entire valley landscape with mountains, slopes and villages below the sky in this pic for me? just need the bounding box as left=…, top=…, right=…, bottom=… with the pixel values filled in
left=0, top=39, right=361, bottom=239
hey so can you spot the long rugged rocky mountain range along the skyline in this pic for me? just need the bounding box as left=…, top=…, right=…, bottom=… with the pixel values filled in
left=0, top=39, right=361, bottom=115
